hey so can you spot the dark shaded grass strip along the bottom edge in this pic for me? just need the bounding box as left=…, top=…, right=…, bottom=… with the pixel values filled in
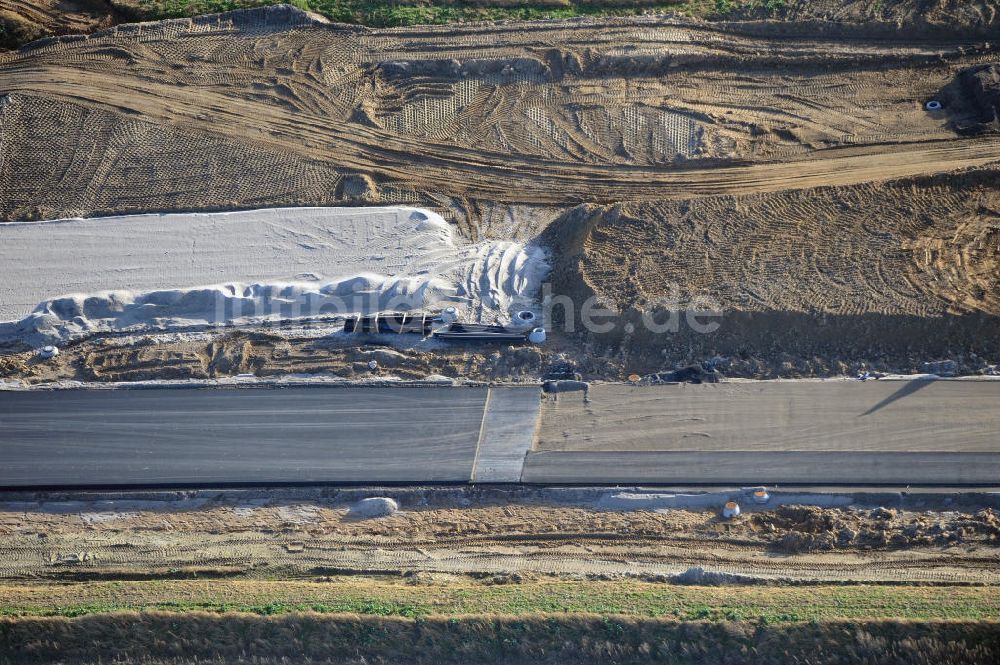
left=0, top=612, right=1000, bottom=665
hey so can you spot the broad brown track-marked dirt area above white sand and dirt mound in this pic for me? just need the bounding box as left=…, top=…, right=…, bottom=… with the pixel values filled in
left=0, top=9, right=997, bottom=218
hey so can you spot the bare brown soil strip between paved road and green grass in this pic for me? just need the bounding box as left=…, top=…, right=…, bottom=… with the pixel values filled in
left=0, top=490, right=1000, bottom=585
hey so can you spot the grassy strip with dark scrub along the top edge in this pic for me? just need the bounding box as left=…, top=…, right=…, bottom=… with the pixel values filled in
left=0, top=0, right=998, bottom=48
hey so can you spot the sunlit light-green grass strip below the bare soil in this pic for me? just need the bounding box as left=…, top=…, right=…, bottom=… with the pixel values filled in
left=0, top=576, right=1000, bottom=624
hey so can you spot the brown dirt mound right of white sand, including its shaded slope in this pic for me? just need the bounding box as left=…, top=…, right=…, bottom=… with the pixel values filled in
left=546, top=168, right=1000, bottom=378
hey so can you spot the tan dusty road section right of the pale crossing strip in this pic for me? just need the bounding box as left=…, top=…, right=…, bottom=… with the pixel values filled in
left=521, top=380, right=1000, bottom=486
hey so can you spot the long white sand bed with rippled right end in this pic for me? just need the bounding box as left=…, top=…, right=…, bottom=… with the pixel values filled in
left=0, top=208, right=548, bottom=345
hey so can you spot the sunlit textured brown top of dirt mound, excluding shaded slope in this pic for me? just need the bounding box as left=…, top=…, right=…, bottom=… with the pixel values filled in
left=564, top=169, right=1000, bottom=317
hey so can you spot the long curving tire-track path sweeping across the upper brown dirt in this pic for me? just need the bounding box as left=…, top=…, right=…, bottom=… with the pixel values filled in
left=5, top=71, right=1000, bottom=204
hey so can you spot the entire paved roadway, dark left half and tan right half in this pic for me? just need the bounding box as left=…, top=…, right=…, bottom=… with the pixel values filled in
left=0, top=381, right=1000, bottom=488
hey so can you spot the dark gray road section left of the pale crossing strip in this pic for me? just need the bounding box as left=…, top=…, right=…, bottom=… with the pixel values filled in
left=0, top=387, right=487, bottom=487
